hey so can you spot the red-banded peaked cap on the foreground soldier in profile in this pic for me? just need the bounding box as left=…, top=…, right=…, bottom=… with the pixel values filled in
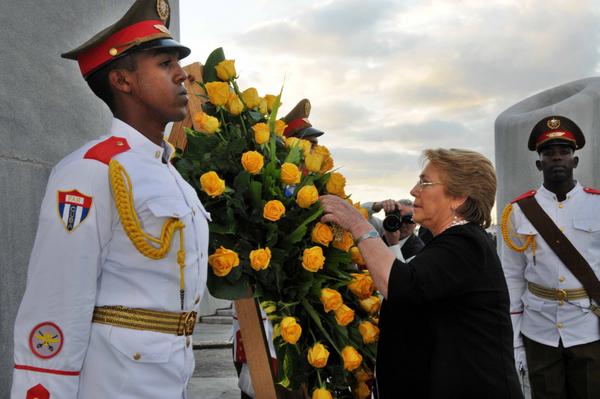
left=61, top=0, right=190, bottom=79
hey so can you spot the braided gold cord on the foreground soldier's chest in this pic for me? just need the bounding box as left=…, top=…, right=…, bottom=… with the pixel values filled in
left=108, top=159, right=185, bottom=310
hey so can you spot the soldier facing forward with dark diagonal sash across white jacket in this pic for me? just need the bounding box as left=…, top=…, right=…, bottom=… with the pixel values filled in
left=500, top=116, right=600, bottom=399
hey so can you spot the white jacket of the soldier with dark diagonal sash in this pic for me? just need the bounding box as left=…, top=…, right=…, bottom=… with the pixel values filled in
left=500, top=183, right=600, bottom=347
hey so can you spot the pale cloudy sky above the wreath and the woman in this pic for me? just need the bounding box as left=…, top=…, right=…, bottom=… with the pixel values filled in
left=180, top=0, right=600, bottom=206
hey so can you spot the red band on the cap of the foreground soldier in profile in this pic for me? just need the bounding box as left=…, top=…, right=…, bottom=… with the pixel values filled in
left=77, top=20, right=171, bottom=78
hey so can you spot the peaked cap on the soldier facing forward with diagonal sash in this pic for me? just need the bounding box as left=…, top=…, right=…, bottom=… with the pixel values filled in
left=527, top=115, right=585, bottom=151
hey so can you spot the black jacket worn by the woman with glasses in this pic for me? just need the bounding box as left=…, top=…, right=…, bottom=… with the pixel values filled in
left=376, top=224, right=523, bottom=399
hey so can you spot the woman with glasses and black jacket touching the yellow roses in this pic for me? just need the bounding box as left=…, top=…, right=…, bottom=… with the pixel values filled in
left=321, top=149, right=522, bottom=399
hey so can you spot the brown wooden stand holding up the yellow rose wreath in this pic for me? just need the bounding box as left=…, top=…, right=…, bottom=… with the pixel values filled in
left=169, top=62, right=281, bottom=399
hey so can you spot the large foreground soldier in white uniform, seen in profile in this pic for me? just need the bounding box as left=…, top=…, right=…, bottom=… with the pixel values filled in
left=11, top=0, right=209, bottom=399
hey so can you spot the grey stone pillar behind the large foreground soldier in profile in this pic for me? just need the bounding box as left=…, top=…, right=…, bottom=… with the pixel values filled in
left=0, top=0, right=179, bottom=399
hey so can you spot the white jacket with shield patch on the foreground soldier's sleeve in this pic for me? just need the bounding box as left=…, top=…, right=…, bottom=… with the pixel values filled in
left=11, top=119, right=210, bottom=399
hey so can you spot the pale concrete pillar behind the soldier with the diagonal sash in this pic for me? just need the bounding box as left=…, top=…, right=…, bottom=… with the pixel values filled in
left=495, top=77, right=600, bottom=220
